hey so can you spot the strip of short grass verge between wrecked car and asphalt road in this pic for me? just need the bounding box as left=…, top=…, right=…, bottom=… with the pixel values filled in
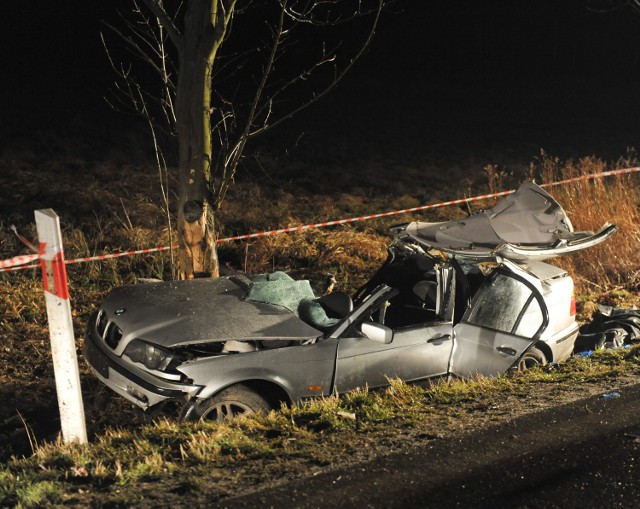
left=0, top=347, right=640, bottom=507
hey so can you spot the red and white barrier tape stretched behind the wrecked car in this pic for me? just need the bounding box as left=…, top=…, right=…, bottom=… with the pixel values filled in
left=0, top=167, right=640, bottom=272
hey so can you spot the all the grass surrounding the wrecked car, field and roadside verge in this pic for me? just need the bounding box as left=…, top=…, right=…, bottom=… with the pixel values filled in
left=0, top=125, right=640, bottom=507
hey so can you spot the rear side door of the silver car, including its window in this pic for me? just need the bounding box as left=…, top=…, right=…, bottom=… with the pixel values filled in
left=450, top=268, right=549, bottom=378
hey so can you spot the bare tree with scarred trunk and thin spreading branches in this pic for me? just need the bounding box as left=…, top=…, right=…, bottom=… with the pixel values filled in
left=112, top=0, right=382, bottom=279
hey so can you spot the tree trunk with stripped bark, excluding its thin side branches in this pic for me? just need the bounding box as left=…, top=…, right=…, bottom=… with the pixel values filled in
left=176, top=0, right=235, bottom=279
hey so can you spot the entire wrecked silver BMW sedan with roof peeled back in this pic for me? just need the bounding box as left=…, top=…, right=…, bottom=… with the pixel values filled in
left=83, top=183, right=615, bottom=420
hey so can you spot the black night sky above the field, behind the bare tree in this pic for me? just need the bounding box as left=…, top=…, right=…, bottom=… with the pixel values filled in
left=0, top=0, right=640, bottom=162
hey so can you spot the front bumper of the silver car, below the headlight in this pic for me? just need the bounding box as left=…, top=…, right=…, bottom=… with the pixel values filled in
left=82, top=331, right=201, bottom=410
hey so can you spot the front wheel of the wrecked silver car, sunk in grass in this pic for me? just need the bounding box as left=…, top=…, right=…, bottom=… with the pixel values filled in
left=188, top=385, right=271, bottom=422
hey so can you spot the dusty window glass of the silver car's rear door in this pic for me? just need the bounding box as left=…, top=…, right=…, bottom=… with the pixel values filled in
left=466, top=274, right=542, bottom=335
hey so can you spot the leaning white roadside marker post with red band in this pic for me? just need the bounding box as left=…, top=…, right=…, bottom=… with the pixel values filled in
left=35, top=209, right=87, bottom=444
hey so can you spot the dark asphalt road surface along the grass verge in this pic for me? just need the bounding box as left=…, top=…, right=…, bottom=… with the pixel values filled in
left=220, top=385, right=640, bottom=509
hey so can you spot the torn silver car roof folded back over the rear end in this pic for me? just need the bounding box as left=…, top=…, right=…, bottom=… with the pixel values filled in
left=403, top=182, right=616, bottom=262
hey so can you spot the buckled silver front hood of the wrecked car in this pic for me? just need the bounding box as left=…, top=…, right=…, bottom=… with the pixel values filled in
left=102, top=276, right=322, bottom=349
